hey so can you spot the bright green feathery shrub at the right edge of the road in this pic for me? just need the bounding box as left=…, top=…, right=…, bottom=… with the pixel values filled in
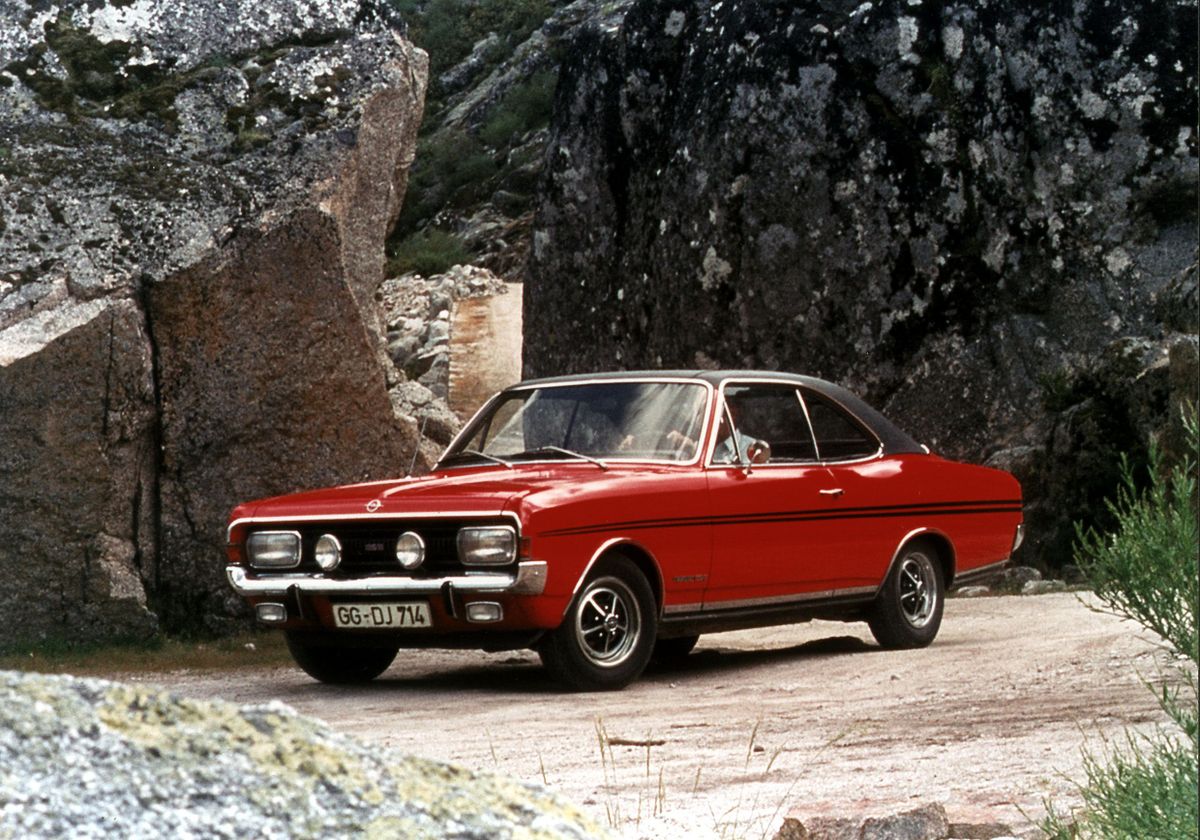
left=1042, top=410, right=1200, bottom=840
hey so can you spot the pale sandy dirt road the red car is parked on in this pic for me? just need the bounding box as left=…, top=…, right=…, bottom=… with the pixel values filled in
left=119, top=593, right=1165, bottom=839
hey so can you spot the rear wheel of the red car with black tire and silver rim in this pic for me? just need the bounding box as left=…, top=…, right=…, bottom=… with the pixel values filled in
left=868, top=542, right=946, bottom=650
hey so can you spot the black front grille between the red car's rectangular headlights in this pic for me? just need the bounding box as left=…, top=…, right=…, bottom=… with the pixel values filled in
left=253, top=520, right=511, bottom=578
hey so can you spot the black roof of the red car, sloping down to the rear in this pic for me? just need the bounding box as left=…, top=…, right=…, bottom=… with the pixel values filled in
left=505, top=370, right=928, bottom=455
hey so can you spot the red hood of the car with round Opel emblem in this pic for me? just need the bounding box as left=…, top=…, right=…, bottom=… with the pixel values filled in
left=234, top=463, right=644, bottom=518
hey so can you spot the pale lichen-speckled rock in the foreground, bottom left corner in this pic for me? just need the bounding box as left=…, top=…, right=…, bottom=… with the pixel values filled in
left=0, top=672, right=605, bottom=840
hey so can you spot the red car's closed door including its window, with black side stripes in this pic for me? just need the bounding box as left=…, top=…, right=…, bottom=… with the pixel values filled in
left=704, top=380, right=842, bottom=610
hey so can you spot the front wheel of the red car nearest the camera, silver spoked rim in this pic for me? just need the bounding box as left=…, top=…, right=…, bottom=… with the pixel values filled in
left=538, top=557, right=656, bottom=691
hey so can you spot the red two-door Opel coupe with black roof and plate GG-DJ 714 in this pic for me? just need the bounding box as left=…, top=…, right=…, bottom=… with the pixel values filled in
left=228, top=371, right=1022, bottom=690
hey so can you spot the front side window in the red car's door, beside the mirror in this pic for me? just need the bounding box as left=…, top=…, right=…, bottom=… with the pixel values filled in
left=713, top=385, right=816, bottom=463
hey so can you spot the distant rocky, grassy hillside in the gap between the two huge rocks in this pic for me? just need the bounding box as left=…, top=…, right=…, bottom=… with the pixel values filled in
left=392, top=0, right=630, bottom=282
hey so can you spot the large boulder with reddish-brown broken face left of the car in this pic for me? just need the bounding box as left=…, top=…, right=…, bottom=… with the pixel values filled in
left=0, top=0, right=426, bottom=647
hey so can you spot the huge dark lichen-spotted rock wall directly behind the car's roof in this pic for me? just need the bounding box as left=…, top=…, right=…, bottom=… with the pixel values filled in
left=524, top=0, right=1198, bottom=571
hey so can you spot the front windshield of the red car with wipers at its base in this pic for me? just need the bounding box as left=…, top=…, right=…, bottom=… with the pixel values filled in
left=442, top=382, right=707, bottom=463
